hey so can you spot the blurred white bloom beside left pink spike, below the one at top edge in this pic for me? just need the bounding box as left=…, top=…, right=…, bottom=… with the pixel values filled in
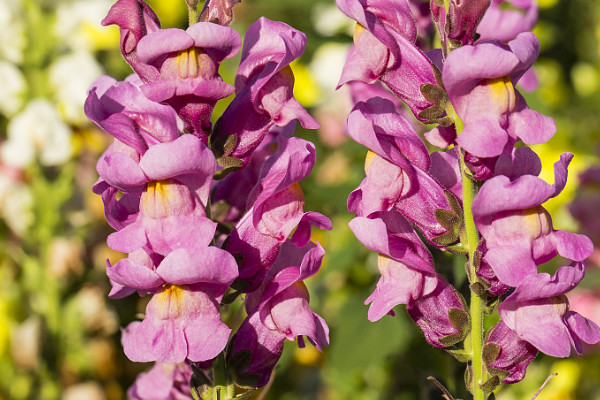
left=49, top=51, right=102, bottom=125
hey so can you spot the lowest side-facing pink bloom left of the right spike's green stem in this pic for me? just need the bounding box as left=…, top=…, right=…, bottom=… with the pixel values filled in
left=349, top=211, right=468, bottom=347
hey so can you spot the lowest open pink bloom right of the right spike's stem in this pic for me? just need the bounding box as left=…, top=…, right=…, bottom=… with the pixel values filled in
left=498, top=262, right=600, bottom=357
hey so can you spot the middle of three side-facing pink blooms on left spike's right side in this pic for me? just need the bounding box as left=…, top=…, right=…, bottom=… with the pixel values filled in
left=225, top=136, right=331, bottom=291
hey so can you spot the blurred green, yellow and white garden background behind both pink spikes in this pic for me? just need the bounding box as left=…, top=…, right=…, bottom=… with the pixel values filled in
left=0, top=0, right=600, bottom=400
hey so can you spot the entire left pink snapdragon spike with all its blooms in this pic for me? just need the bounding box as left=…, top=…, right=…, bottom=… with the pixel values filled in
left=85, top=0, right=331, bottom=399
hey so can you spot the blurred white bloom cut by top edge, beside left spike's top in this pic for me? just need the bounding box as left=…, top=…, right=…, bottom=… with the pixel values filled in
left=55, top=0, right=118, bottom=50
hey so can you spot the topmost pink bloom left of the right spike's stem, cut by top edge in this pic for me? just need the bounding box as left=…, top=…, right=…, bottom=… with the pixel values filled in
left=336, top=0, right=446, bottom=122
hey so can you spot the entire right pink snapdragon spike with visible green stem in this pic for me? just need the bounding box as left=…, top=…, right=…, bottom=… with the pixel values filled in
left=337, top=0, right=600, bottom=393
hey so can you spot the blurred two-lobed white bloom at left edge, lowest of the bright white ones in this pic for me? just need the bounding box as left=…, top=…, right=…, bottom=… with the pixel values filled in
left=0, top=99, right=73, bottom=168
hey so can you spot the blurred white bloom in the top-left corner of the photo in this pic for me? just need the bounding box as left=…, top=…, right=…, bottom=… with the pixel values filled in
left=0, top=0, right=26, bottom=63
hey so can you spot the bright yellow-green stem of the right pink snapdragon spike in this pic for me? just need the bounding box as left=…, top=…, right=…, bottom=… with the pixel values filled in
left=457, top=148, right=485, bottom=400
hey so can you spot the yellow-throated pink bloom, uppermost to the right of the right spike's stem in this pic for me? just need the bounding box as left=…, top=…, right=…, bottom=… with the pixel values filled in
left=442, top=32, right=556, bottom=157
